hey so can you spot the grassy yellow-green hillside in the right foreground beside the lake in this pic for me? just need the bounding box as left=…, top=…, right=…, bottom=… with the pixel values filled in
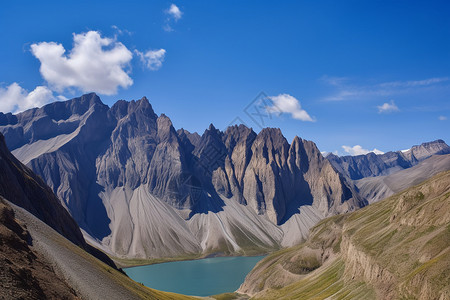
left=238, top=171, right=450, bottom=299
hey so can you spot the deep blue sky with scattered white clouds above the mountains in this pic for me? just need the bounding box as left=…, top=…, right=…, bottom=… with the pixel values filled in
left=0, top=0, right=450, bottom=154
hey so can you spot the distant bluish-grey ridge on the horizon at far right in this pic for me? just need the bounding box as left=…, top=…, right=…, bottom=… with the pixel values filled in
left=327, top=140, right=450, bottom=180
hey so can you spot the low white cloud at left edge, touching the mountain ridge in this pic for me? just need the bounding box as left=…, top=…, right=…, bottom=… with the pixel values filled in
left=0, top=82, right=59, bottom=113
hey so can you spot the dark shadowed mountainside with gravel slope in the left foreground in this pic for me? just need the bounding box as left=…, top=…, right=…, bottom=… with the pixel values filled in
left=0, top=127, right=194, bottom=299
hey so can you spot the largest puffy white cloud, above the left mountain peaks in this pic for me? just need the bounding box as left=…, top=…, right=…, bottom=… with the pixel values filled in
left=31, top=31, right=133, bottom=95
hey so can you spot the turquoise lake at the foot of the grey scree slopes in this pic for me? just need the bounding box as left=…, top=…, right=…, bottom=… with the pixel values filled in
left=124, top=256, right=264, bottom=296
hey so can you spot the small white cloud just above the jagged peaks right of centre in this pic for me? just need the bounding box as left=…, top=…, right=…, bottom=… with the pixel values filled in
left=266, top=94, right=315, bottom=122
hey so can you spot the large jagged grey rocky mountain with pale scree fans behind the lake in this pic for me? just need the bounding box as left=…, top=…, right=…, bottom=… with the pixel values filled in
left=0, top=94, right=367, bottom=258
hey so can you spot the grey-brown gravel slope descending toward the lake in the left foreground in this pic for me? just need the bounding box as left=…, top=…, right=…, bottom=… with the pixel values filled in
left=11, top=200, right=196, bottom=300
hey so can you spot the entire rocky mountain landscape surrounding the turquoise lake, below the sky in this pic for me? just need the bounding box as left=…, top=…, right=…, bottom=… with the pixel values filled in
left=0, top=93, right=450, bottom=299
